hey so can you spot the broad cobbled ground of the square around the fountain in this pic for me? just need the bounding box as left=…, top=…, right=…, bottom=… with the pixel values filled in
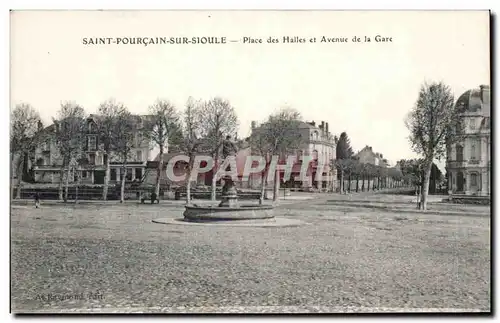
left=11, top=197, right=490, bottom=312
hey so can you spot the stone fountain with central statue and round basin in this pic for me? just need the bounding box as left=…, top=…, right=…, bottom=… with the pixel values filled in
left=184, top=136, right=274, bottom=222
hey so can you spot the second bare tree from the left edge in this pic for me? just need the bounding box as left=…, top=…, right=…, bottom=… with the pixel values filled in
left=54, top=102, right=86, bottom=201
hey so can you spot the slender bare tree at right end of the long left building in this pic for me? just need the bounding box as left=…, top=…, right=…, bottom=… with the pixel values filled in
left=145, top=100, right=179, bottom=196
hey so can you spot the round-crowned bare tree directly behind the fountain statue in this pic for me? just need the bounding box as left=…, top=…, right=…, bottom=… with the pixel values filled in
left=200, top=97, right=239, bottom=201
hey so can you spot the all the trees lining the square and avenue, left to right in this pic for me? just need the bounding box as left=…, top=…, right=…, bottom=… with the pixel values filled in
left=10, top=83, right=454, bottom=209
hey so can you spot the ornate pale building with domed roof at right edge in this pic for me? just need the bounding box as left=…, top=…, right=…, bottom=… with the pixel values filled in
left=446, top=85, right=491, bottom=196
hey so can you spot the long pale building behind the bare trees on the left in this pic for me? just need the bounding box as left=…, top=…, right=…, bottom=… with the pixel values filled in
left=33, top=115, right=154, bottom=184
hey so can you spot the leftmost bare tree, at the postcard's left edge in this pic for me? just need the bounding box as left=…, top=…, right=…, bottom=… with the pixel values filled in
left=10, top=103, right=43, bottom=198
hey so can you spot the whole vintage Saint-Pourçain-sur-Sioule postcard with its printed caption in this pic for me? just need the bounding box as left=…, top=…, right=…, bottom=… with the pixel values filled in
left=9, top=10, right=492, bottom=314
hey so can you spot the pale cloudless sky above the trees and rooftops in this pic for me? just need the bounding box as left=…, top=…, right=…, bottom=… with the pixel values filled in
left=11, top=11, right=490, bottom=165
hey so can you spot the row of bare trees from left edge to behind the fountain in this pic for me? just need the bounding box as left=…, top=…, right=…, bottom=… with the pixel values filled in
left=10, top=98, right=238, bottom=201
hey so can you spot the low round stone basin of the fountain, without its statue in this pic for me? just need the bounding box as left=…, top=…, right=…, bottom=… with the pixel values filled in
left=184, top=205, right=274, bottom=222
